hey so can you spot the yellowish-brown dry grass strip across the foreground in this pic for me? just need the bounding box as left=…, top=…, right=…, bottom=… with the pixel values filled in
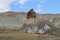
left=0, top=31, right=60, bottom=40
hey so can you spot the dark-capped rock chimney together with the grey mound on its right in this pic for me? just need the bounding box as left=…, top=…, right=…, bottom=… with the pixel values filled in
left=22, top=9, right=56, bottom=34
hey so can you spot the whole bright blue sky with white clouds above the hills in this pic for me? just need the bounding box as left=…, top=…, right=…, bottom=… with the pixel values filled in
left=0, top=0, right=60, bottom=14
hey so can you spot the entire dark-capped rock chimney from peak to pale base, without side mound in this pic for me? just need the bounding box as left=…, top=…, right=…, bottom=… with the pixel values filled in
left=26, top=9, right=38, bottom=33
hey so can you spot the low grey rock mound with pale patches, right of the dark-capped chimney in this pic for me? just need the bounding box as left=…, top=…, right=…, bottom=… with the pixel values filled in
left=37, top=20, right=56, bottom=34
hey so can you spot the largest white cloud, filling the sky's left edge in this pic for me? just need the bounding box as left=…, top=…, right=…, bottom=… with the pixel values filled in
left=0, top=0, right=14, bottom=12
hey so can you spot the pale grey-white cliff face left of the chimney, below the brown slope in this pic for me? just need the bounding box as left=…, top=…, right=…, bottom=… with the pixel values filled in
left=0, top=17, right=25, bottom=29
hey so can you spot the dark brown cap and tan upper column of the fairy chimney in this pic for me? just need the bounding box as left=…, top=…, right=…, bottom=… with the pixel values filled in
left=26, top=9, right=36, bottom=25
